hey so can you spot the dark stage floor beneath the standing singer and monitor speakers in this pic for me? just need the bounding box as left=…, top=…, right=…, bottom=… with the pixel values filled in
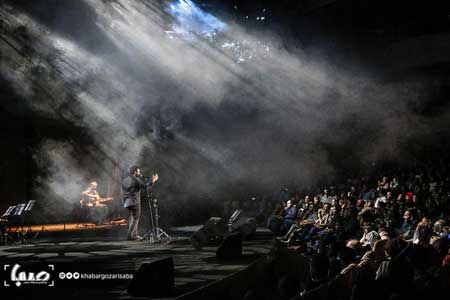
left=0, top=226, right=272, bottom=299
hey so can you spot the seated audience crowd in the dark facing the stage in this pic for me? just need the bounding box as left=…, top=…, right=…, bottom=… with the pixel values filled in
left=255, top=160, right=450, bottom=300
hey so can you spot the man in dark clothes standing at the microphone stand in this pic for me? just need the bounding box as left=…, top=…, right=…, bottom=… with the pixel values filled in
left=122, top=166, right=158, bottom=240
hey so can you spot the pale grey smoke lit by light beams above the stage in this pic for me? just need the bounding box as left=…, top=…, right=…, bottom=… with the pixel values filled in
left=2, top=0, right=446, bottom=220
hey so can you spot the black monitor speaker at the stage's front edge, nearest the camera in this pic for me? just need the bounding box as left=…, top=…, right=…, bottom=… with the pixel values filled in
left=128, top=257, right=175, bottom=297
